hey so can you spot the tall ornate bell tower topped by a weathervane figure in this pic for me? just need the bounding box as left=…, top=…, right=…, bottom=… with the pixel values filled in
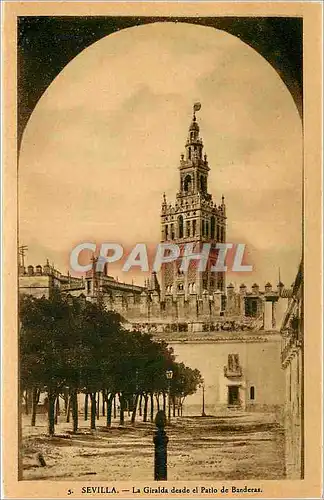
left=161, top=103, right=226, bottom=300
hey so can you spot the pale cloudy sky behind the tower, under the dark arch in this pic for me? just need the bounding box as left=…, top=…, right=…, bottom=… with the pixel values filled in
left=19, top=23, right=302, bottom=286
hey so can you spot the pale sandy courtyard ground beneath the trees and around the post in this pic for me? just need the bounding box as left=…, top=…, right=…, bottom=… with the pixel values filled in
left=21, top=412, right=285, bottom=481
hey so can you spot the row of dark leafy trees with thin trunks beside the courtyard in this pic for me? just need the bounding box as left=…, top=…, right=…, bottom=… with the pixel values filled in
left=19, top=293, right=201, bottom=434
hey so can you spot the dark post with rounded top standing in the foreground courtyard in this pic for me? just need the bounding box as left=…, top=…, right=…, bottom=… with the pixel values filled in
left=153, top=410, right=169, bottom=481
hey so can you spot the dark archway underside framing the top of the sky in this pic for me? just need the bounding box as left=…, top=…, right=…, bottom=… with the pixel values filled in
left=17, top=16, right=303, bottom=147
